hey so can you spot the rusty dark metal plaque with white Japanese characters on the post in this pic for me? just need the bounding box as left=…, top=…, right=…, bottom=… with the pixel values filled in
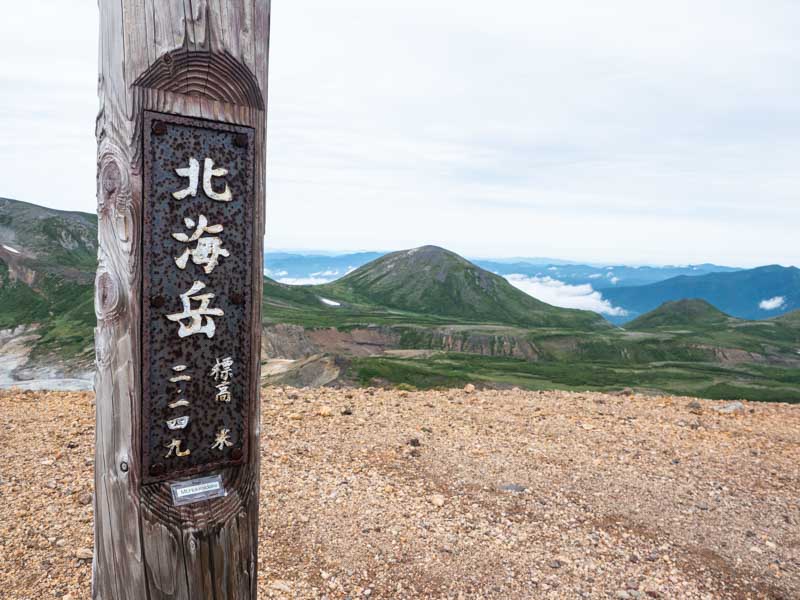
left=141, top=112, right=253, bottom=483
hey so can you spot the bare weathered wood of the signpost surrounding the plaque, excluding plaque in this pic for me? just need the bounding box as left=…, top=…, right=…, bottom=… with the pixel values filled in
left=92, top=0, right=270, bottom=600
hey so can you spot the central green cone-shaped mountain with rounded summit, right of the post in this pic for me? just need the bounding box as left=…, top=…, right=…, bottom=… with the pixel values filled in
left=318, top=246, right=608, bottom=330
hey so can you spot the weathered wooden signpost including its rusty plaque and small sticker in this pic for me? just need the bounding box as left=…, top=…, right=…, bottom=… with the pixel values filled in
left=92, top=0, right=270, bottom=600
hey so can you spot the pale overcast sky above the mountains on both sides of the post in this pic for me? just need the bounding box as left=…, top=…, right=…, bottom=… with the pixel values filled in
left=0, top=0, right=800, bottom=266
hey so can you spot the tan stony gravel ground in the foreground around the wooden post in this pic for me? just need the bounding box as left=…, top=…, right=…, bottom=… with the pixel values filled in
left=0, top=386, right=800, bottom=600
